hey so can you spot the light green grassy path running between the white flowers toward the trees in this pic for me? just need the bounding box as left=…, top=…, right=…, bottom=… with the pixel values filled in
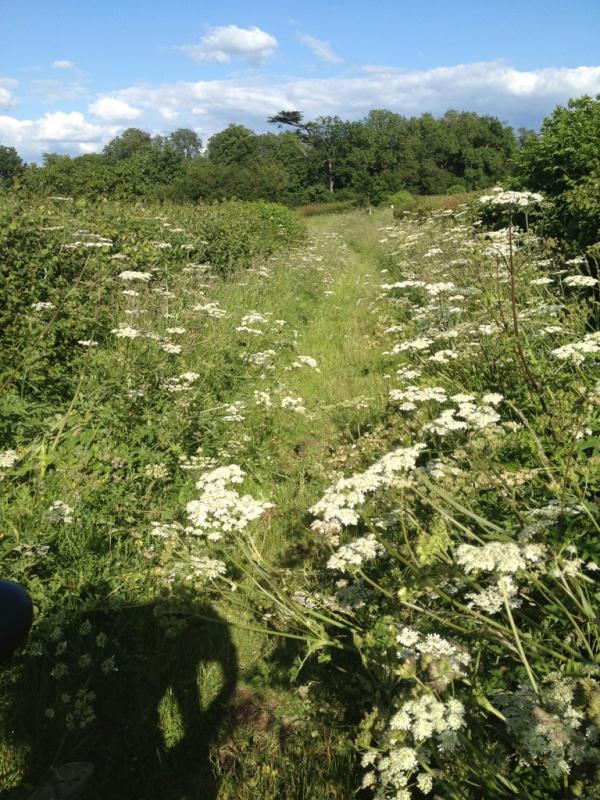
left=191, top=213, right=398, bottom=800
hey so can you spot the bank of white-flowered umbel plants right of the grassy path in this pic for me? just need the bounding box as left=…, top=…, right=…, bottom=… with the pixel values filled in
left=164, top=197, right=600, bottom=800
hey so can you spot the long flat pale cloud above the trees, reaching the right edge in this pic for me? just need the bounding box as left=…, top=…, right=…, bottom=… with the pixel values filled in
left=115, top=61, right=600, bottom=130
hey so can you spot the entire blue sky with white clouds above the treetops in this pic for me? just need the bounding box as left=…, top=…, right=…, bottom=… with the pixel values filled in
left=0, top=0, right=600, bottom=160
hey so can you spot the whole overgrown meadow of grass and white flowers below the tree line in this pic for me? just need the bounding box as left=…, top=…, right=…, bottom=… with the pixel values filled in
left=0, top=184, right=600, bottom=800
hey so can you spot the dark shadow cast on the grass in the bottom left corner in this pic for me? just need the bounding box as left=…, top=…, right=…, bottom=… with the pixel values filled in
left=2, top=600, right=238, bottom=800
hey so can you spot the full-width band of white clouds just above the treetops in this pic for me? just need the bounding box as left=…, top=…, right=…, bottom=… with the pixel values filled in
left=5, top=61, right=600, bottom=155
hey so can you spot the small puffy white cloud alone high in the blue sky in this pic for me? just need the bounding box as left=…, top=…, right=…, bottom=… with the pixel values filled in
left=178, top=25, right=277, bottom=66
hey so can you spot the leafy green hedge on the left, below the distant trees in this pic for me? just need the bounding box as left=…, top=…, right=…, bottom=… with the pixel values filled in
left=0, top=199, right=303, bottom=424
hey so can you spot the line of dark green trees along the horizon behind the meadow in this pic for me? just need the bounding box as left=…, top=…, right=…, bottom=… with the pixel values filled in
left=0, top=110, right=525, bottom=206
